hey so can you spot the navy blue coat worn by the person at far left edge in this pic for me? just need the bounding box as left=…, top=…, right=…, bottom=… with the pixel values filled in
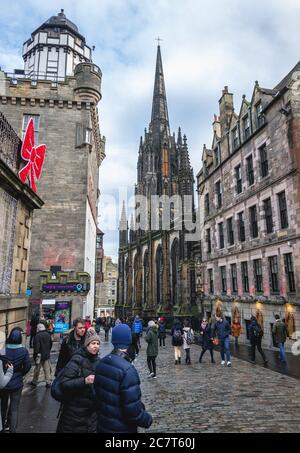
left=5, top=345, right=31, bottom=391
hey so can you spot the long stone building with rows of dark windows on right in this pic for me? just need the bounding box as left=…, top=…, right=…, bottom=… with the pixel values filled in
left=197, top=63, right=300, bottom=347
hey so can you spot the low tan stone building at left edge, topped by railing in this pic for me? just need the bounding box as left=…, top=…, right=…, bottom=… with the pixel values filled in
left=0, top=112, right=43, bottom=336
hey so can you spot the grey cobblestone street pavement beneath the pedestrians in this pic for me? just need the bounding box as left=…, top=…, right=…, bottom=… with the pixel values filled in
left=18, top=332, right=300, bottom=433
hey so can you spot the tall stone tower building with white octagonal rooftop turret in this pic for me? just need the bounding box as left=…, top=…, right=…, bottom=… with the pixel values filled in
left=0, top=12, right=105, bottom=317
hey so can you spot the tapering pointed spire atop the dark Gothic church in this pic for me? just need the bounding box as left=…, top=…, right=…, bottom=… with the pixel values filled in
left=149, top=45, right=170, bottom=136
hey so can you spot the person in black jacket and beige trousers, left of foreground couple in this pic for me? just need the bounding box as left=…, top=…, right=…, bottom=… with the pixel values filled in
left=30, top=324, right=52, bottom=388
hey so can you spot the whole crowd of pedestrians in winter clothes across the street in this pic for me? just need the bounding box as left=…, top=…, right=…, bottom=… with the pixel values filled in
left=0, top=313, right=288, bottom=433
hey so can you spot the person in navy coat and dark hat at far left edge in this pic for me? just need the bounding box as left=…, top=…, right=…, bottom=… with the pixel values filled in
left=1, top=327, right=31, bottom=433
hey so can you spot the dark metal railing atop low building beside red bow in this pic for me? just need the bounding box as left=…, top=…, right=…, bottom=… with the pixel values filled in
left=0, top=112, right=22, bottom=173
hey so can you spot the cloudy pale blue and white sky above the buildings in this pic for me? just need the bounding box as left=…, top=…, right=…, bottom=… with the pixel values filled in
left=0, top=0, right=300, bottom=259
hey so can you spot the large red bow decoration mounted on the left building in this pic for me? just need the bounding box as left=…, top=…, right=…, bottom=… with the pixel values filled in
left=19, top=118, right=46, bottom=192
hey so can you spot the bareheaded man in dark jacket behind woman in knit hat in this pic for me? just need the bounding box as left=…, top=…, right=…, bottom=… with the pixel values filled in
left=55, top=318, right=86, bottom=376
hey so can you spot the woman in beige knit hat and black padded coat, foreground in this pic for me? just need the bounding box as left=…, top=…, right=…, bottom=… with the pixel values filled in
left=56, top=329, right=100, bottom=433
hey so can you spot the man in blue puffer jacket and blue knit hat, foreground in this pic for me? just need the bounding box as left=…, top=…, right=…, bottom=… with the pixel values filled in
left=94, top=324, right=152, bottom=433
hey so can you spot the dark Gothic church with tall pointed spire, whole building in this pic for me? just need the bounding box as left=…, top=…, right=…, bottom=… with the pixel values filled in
left=116, top=46, right=195, bottom=319
